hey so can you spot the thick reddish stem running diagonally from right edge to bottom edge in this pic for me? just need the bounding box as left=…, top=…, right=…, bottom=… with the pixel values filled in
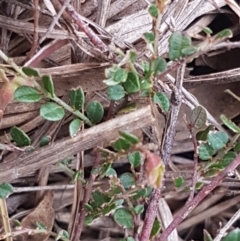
left=157, top=154, right=240, bottom=241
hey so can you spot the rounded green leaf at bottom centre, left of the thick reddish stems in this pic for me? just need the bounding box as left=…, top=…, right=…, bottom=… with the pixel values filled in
left=113, top=208, right=133, bottom=229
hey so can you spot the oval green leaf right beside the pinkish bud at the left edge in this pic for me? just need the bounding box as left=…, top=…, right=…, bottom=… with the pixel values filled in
left=14, top=86, right=41, bottom=103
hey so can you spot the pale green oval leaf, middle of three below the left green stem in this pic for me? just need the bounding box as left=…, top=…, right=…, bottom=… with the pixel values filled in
left=40, top=102, right=65, bottom=121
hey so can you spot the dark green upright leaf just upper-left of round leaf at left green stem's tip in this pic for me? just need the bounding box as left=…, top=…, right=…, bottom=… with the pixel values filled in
left=69, top=87, right=85, bottom=111
